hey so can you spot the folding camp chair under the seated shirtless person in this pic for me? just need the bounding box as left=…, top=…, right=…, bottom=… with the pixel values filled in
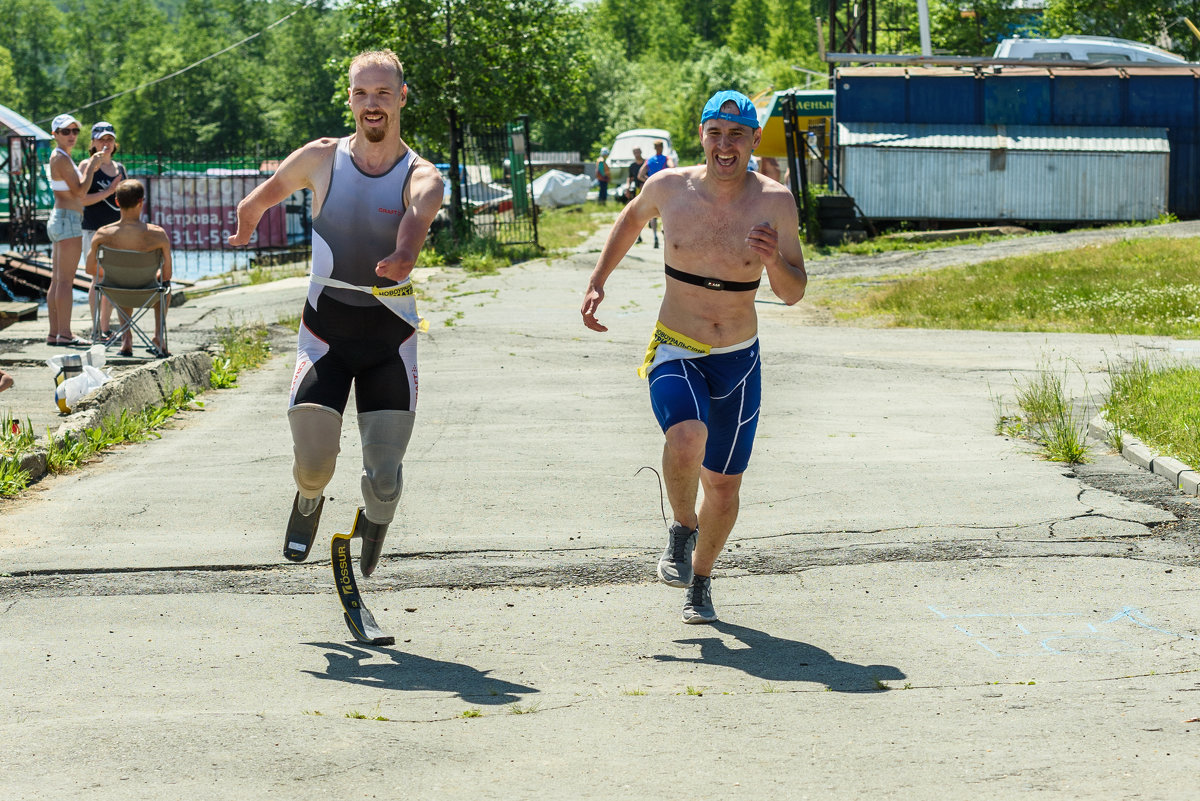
left=91, top=245, right=170, bottom=353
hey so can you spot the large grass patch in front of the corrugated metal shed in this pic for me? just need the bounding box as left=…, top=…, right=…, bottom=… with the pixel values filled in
left=823, top=239, right=1200, bottom=338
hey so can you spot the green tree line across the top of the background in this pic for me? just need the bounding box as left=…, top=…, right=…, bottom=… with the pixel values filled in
left=0, top=0, right=1200, bottom=159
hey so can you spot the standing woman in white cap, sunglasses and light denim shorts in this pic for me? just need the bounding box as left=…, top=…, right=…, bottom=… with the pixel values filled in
left=46, top=114, right=116, bottom=347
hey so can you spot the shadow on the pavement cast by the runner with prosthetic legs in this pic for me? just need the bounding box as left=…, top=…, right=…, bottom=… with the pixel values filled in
left=304, top=643, right=539, bottom=704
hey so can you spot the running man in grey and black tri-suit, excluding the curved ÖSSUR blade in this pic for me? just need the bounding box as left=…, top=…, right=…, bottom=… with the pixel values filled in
left=229, top=50, right=443, bottom=576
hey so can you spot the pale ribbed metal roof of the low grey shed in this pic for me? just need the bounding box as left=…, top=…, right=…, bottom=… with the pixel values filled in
left=838, top=122, right=1171, bottom=153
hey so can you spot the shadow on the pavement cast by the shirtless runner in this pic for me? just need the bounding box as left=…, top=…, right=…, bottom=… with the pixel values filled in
left=654, top=620, right=905, bottom=693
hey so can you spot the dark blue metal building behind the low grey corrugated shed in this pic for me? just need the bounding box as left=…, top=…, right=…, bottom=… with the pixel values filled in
left=834, top=66, right=1200, bottom=218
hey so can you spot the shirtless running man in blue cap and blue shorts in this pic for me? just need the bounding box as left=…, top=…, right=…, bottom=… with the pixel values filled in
left=581, top=90, right=808, bottom=624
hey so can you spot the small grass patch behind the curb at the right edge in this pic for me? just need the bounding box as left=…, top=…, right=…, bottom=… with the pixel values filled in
left=1103, top=357, right=1200, bottom=468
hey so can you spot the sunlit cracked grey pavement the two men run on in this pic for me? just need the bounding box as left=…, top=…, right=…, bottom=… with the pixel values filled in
left=0, top=230, right=1200, bottom=800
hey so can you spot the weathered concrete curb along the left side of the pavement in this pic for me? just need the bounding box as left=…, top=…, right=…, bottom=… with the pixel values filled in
left=12, top=350, right=212, bottom=483
